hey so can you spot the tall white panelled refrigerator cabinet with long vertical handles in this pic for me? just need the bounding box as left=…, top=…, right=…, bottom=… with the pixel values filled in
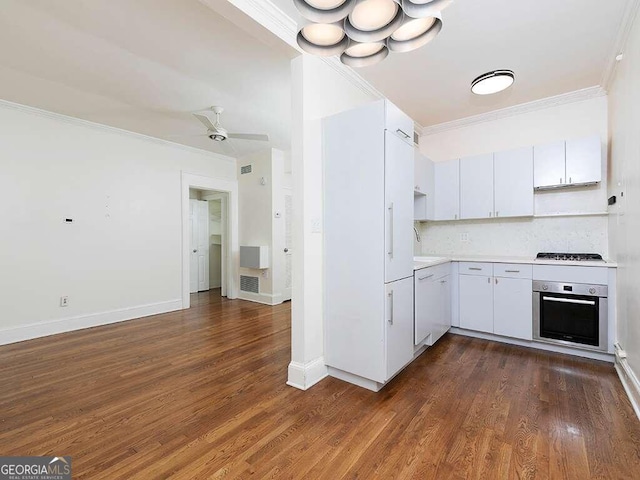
left=323, top=100, right=414, bottom=391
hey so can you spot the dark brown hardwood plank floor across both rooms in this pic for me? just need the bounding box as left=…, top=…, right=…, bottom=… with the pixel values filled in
left=0, top=291, right=640, bottom=480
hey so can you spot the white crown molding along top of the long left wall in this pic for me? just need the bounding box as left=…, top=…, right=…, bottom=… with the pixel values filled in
left=0, top=99, right=236, bottom=163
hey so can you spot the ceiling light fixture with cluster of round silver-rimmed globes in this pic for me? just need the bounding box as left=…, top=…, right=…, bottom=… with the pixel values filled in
left=293, top=0, right=453, bottom=67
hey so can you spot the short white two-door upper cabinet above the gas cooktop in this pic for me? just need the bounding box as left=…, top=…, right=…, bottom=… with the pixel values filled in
left=534, top=135, right=602, bottom=189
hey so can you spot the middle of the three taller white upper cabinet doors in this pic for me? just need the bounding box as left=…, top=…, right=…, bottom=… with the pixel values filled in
left=460, top=153, right=494, bottom=219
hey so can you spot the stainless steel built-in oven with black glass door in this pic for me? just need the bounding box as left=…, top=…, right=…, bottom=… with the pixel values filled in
left=533, top=280, right=608, bottom=351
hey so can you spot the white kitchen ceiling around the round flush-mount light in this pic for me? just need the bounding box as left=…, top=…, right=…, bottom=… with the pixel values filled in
left=273, top=0, right=629, bottom=126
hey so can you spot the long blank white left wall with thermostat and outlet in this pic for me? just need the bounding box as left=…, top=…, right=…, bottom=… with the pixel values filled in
left=0, top=102, right=235, bottom=343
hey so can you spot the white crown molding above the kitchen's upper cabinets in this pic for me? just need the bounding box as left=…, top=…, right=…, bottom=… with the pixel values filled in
left=422, top=86, right=607, bottom=135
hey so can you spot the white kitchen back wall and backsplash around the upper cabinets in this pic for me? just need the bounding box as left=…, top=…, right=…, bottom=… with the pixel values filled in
left=420, top=96, right=609, bottom=258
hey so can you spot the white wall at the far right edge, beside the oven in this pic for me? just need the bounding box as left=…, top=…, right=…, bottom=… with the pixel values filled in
left=609, top=9, right=640, bottom=415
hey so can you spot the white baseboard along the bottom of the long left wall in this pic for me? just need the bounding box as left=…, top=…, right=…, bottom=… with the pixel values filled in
left=0, top=300, right=182, bottom=345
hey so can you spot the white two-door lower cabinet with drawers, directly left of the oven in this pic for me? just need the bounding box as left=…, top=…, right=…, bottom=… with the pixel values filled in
left=459, top=263, right=533, bottom=340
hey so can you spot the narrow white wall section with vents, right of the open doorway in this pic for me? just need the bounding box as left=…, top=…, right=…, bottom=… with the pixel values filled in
left=237, top=149, right=284, bottom=305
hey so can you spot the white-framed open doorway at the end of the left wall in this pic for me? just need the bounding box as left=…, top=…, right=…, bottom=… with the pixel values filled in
left=182, top=173, right=239, bottom=308
